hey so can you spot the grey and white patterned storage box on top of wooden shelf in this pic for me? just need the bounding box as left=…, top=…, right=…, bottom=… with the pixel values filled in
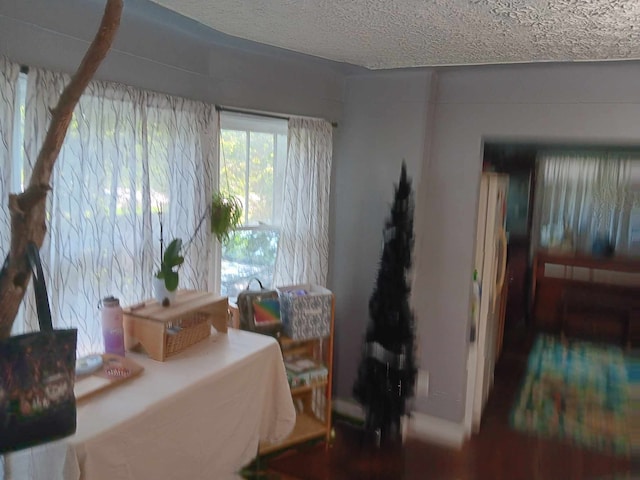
left=276, top=284, right=333, bottom=340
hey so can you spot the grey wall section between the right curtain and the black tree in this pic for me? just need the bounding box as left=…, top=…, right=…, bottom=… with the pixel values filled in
left=329, top=70, right=431, bottom=399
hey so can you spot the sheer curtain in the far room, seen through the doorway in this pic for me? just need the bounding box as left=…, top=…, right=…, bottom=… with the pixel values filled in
left=534, top=151, right=640, bottom=254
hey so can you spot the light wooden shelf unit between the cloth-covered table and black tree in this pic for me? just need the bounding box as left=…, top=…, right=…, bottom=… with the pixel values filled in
left=258, top=297, right=335, bottom=455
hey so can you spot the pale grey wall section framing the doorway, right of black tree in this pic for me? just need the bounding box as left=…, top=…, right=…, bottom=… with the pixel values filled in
left=414, top=62, right=640, bottom=422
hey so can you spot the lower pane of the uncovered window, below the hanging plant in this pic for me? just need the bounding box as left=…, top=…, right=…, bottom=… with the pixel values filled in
left=220, top=229, right=279, bottom=297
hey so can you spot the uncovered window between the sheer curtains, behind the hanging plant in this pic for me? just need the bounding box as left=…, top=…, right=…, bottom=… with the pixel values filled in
left=219, top=113, right=287, bottom=297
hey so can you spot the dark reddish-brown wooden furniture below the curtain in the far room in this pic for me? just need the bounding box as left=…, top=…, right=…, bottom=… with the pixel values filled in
left=531, top=251, right=640, bottom=346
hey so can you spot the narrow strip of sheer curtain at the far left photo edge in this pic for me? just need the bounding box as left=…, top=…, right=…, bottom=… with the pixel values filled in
left=0, top=56, right=20, bottom=256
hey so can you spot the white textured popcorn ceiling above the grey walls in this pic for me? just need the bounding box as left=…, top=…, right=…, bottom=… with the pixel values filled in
left=153, top=0, right=640, bottom=69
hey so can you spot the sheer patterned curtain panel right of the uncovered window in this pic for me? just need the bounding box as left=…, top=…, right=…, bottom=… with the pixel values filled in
left=273, top=118, right=333, bottom=286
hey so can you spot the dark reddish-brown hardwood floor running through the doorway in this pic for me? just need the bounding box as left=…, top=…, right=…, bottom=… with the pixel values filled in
left=261, top=332, right=640, bottom=480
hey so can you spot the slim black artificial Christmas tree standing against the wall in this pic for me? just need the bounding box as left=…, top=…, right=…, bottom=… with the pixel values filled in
left=353, top=162, right=416, bottom=442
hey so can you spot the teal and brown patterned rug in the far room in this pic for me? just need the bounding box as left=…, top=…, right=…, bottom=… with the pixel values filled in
left=511, top=335, right=640, bottom=455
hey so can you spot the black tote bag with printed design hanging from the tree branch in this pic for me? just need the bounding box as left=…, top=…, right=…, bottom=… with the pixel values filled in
left=0, top=243, right=78, bottom=453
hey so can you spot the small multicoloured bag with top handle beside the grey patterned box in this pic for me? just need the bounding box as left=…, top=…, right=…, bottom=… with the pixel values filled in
left=238, top=278, right=282, bottom=336
